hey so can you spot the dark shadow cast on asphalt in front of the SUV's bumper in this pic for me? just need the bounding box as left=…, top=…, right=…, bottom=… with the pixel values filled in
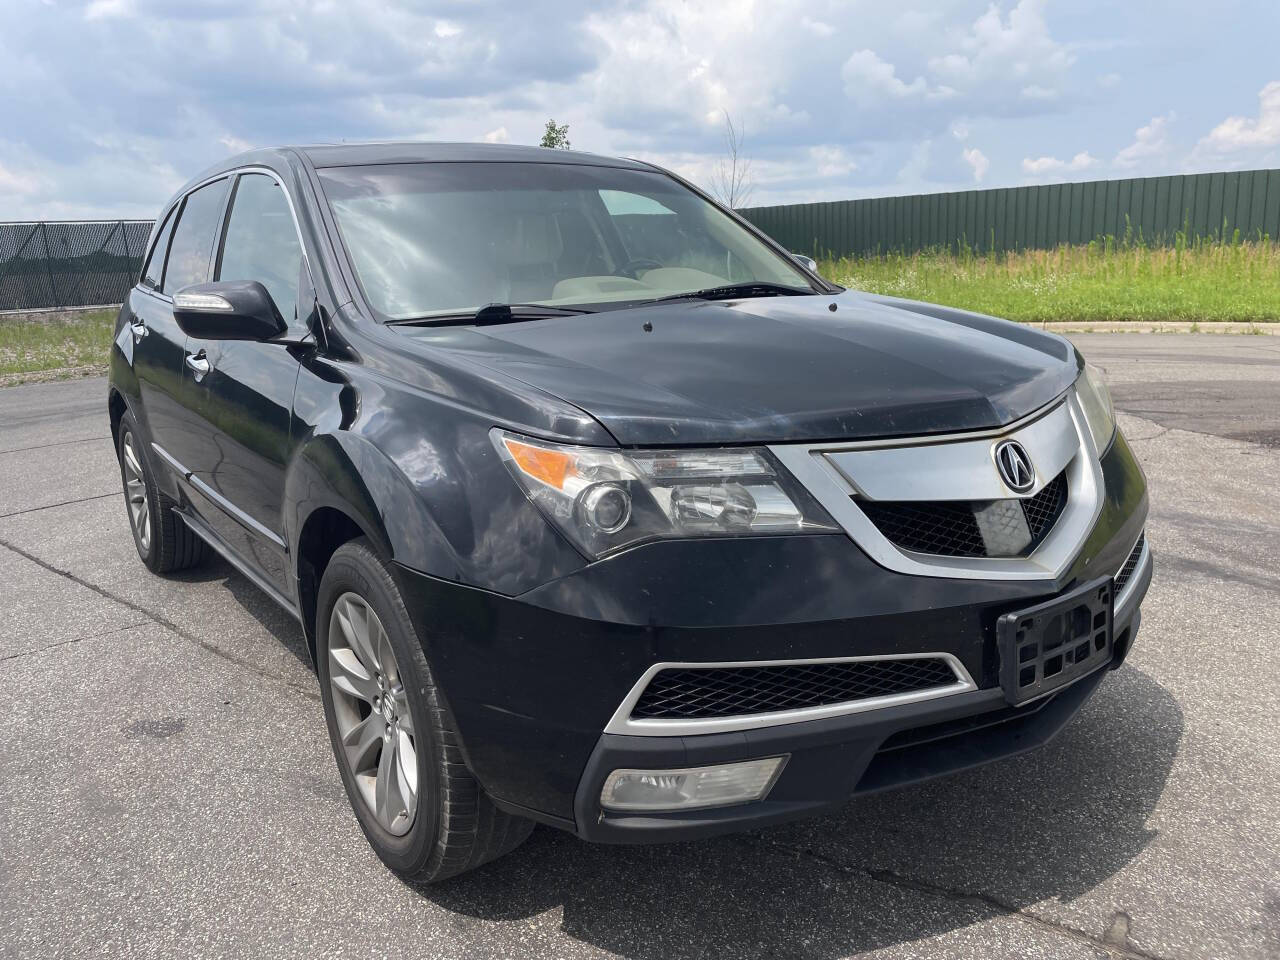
left=415, top=667, right=1183, bottom=960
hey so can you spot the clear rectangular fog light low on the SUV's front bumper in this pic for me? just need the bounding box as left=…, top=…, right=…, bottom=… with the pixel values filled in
left=600, top=756, right=787, bottom=810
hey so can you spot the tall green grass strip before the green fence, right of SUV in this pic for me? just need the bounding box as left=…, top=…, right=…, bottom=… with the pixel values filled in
left=822, top=234, right=1280, bottom=323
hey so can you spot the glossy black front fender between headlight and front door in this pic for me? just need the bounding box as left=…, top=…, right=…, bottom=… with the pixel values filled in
left=285, top=360, right=585, bottom=595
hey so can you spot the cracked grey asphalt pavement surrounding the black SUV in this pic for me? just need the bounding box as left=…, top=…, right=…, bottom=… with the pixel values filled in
left=0, top=334, right=1280, bottom=960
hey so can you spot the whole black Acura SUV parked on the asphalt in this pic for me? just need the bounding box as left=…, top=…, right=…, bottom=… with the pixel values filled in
left=109, top=143, right=1152, bottom=879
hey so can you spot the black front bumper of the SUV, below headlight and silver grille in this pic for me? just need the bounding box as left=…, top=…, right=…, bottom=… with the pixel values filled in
left=398, top=427, right=1151, bottom=842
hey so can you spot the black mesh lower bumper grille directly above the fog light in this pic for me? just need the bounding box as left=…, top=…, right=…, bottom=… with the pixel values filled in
left=631, top=657, right=957, bottom=719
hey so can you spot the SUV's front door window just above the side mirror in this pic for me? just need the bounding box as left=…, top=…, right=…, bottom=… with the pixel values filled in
left=218, top=173, right=302, bottom=323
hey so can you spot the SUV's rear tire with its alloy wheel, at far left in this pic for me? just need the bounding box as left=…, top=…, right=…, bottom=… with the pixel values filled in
left=115, top=411, right=209, bottom=573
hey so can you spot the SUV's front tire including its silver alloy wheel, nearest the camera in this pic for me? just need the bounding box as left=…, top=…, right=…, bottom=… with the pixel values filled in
left=316, top=538, right=534, bottom=883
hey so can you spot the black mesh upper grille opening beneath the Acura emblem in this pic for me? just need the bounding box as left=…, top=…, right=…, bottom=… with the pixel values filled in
left=858, top=470, right=1066, bottom=557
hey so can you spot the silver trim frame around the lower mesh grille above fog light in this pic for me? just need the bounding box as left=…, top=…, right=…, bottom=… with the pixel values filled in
left=604, top=653, right=978, bottom=737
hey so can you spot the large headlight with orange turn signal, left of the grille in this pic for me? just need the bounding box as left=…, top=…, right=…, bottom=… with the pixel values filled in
left=492, top=429, right=838, bottom=557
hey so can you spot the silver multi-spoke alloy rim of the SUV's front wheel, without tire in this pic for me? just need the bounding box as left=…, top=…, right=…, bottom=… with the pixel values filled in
left=329, top=591, right=417, bottom=836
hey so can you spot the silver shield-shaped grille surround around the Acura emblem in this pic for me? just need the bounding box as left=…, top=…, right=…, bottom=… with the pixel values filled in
left=769, top=388, right=1103, bottom=580
